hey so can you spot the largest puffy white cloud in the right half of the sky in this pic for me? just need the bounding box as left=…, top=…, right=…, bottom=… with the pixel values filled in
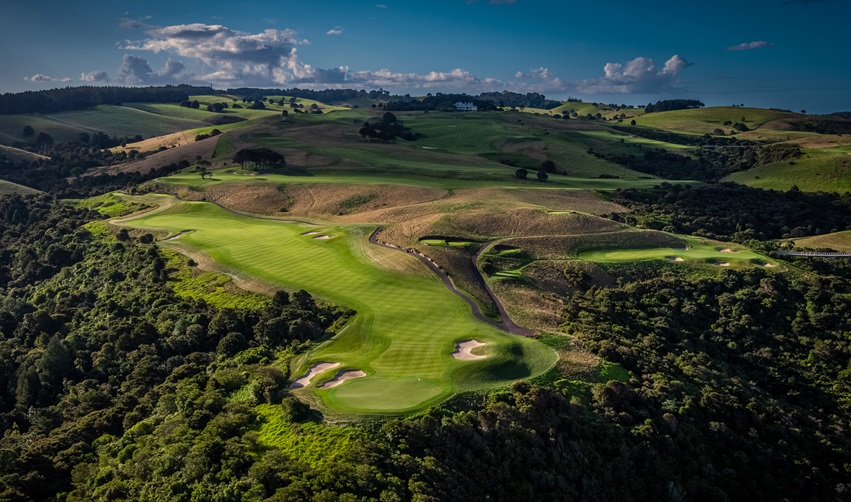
left=576, top=54, right=692, bottom=94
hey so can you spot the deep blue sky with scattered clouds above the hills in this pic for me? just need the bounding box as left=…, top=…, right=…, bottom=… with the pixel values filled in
left=0, top=0, right=851, bottom=113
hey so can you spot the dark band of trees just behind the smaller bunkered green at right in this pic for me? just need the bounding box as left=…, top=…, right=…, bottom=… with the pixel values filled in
left=615, top=183, right=851, bottom=243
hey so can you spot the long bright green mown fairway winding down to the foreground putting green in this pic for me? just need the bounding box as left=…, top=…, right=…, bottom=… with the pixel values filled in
left=123, top=199, right=557, bottom=414
